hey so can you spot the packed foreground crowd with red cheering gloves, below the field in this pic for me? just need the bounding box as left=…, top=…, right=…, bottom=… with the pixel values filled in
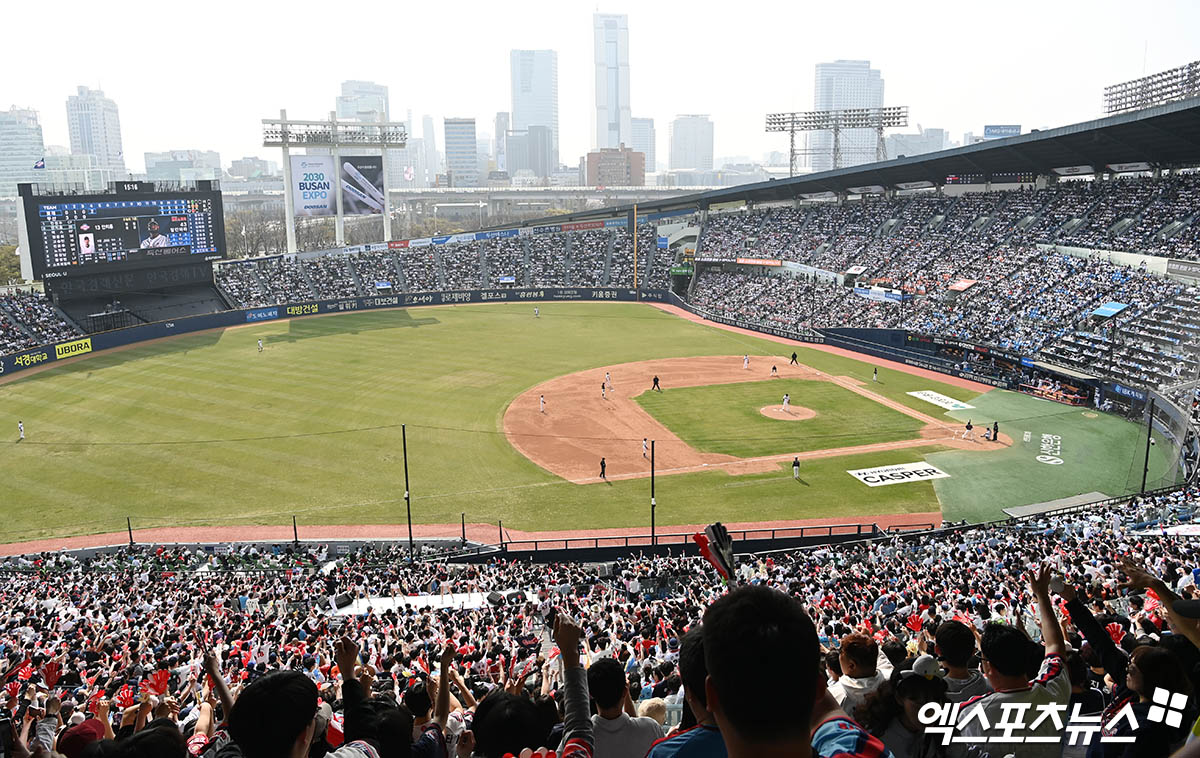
left=0, top=489, right=1200, bottom=758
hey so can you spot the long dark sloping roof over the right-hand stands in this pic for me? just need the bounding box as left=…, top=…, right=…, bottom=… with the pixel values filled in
left=546, top=97, right=1200, bottom=223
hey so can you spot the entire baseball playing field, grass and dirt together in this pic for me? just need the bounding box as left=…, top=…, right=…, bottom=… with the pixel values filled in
left=0, top=303, right=1166, bottom=542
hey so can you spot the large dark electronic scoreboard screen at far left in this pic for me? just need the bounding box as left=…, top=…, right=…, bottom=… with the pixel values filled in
left=22, top=191, right=226, bottom=279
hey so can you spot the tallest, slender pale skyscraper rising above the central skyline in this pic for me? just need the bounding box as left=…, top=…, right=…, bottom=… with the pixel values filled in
left=592, top=13, right=632, bottom=148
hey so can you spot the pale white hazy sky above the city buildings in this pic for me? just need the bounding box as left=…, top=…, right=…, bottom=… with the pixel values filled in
left=0, top=0, right=1200, bottom=170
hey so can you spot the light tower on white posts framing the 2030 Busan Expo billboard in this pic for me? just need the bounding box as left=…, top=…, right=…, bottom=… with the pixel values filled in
left=263, top=110, right=408, bottom=253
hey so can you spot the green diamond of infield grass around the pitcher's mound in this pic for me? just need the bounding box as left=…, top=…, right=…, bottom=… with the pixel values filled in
left=636, top=379, right=923, bottom=458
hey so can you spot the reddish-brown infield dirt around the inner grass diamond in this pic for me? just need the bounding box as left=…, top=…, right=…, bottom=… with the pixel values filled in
left=504, top=355, right=1012, bottom=485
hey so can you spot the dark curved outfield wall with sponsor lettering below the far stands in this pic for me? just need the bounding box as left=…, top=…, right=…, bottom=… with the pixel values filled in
left=0, top=287, right=667, bottom=377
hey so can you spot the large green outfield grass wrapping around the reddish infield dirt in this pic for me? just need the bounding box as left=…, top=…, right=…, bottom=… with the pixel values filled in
left=0, top=303, right=1156, bottom=541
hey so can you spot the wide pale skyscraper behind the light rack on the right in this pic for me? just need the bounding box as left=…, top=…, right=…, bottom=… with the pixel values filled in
left=809, top=60, right=883, bottom=172
